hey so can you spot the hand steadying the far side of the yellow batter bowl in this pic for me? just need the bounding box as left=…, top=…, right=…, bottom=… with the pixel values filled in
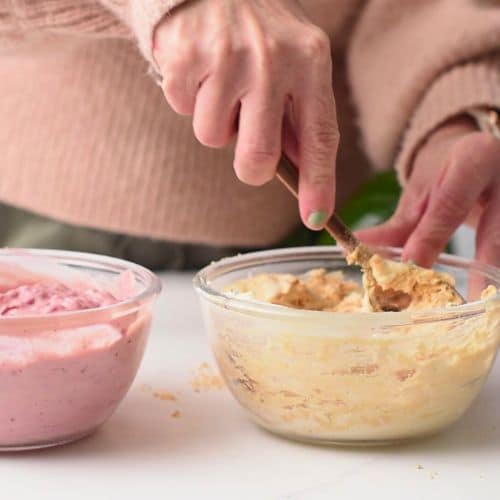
left=358, top=118, right=500, bottom=266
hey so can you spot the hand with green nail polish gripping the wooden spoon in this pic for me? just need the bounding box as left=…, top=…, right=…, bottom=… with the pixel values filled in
left=154, top=0, right=339, bottom=229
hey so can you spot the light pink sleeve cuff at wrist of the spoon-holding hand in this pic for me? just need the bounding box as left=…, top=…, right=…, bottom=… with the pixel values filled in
left=130, top=0, right=186, bottom=71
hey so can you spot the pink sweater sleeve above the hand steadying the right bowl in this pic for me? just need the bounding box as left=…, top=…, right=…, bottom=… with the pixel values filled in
left=348, top=0, right=500, bottom=183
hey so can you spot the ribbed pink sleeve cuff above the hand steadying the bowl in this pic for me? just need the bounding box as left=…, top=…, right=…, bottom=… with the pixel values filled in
left=396, top=53, right=500, bottom=184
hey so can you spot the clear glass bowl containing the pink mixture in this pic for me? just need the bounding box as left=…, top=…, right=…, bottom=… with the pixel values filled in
left=0, top=250, right=161, bottom=451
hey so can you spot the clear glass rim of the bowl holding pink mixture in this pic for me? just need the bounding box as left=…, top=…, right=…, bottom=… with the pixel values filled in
left=0, top=248, right=162, bottom=327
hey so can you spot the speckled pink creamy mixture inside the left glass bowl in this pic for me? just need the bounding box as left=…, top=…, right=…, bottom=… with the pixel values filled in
left=0, top=269, right=151, bottom=449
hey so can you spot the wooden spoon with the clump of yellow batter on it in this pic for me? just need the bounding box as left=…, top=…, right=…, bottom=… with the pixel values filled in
left=277, top=155, right=465, bottom=311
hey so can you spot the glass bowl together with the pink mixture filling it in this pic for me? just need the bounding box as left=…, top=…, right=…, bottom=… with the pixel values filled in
left=0, top=250, right=160, bottom=450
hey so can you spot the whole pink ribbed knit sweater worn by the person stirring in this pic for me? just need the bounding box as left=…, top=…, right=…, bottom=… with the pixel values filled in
left=0, top=0, right=500, bottom=246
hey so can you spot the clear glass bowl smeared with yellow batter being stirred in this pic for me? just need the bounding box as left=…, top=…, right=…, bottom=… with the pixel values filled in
left=195, top=247, right=500, bottom=445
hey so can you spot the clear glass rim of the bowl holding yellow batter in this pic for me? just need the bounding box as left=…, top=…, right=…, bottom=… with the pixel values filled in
left=193, top=245, right=500, bottom=326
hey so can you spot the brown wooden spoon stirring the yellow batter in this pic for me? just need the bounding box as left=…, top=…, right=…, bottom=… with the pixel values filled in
left=276, top=154, right=465, bottom=311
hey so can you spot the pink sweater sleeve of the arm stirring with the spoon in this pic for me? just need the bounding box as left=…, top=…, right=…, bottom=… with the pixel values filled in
left=0, top=0, right=185, bottom=63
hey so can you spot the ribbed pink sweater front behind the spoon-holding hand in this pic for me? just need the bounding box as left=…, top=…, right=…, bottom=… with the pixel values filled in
left=0, top=35, right=297, bottom=245
